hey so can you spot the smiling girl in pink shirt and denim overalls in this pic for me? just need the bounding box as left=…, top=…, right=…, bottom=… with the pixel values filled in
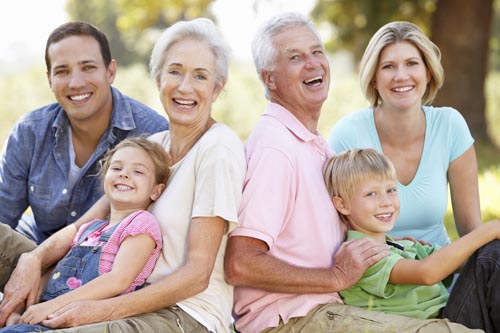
left=0, top=137, right=169, bottom=332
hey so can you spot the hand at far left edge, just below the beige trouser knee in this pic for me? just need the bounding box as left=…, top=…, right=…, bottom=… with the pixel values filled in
left=0, top=253, right=41, bottom=327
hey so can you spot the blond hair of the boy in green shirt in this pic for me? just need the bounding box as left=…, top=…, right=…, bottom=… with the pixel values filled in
left=323, top=148, right=397, bottom=223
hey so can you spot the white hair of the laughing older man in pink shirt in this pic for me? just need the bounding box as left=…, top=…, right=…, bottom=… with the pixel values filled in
left=252, top=12, right=321, bottom=99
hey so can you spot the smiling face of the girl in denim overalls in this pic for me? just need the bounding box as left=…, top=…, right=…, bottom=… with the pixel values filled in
left=104, top=147, right=164, bottom=210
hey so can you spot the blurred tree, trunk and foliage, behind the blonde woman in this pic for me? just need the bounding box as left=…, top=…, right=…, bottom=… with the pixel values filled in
left=311, top=0, right=500, bottom=143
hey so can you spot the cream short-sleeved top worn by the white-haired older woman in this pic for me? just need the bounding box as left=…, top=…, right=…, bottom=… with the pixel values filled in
left=148, top=123, right=246, bottom=332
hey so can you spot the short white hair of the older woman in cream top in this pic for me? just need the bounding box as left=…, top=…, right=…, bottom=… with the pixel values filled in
left=149, top=18, right=230, bottom=87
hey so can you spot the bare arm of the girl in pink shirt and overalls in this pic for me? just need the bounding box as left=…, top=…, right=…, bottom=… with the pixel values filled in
left=21, top=234, right=156, bottom=324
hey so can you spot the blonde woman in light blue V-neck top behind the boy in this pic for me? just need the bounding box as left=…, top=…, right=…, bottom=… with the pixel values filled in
left=329, top=22, right=481, bottom=245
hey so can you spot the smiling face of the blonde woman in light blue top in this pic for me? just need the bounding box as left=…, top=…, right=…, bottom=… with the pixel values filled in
left=373, top=42, right=430, bottom=110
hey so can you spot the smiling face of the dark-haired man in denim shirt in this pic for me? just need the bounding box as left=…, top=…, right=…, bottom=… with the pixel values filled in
left=47, top=36, right=116, bottom=124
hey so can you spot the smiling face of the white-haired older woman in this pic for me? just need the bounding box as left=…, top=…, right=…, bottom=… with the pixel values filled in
left=158, top=39, right=222, bottom=128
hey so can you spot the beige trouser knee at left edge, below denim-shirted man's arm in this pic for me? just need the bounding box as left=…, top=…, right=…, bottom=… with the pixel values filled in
left=0, top=223, right=36, bottom=291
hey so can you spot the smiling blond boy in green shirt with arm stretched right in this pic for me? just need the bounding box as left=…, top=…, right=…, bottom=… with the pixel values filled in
left=324, top=149, right=500, bottom=318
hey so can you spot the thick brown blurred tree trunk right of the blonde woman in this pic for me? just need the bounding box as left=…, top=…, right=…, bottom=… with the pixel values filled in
left=431, top=0, right=493, bottom=143
